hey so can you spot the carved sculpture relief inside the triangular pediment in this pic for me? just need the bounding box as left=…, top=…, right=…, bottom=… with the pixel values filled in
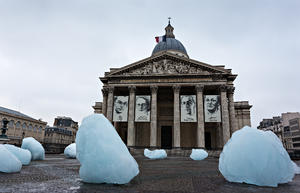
left=125, top=60, right=209, bottom=75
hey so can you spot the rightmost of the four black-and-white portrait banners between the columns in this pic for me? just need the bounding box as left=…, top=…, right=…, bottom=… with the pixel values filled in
left=204, top=95, right=221, bottom=122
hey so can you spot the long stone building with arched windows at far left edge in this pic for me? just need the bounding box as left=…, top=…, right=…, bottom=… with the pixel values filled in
left=0, top=107, right=47, bottom=146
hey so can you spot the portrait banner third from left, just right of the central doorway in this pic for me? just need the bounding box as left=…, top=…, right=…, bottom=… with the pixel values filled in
left=180, top=95, right=197, bottom=122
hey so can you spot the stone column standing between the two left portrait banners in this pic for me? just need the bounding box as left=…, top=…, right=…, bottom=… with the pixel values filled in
left=127, top=86, right=136, bottom=146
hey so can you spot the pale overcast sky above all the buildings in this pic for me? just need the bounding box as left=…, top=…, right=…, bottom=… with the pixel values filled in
left=0, top=0, right=300, bottom=127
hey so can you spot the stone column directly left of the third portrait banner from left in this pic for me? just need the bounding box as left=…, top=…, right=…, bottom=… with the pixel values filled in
left=173, top=85, right=180, bottom=148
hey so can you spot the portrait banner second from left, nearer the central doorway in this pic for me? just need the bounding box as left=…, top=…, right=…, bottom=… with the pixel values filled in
left=135, top=95, right=151, bottom=122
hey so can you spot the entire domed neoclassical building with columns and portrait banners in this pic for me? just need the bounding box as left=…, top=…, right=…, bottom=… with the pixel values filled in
left=93, top=23, right=251, bottom=149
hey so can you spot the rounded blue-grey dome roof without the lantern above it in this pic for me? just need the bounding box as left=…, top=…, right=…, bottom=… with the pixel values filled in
left=152, top=38, right=187, bottom=56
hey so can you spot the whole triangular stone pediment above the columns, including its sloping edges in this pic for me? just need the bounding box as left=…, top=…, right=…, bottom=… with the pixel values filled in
left=107, top=53, right=230, bottom=76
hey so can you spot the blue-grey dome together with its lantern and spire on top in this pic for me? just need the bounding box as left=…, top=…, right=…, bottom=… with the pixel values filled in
left=152, top=21, right=188, bottom=58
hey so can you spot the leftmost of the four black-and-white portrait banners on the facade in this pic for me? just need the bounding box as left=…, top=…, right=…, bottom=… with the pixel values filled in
left=113, top=96, right=128, bottom=122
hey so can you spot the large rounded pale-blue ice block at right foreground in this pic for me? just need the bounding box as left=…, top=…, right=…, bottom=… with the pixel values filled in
left=219, top=126, right=295, bottom=187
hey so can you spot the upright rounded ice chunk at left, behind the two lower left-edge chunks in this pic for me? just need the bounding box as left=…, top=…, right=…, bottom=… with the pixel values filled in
left=21, top=137, right=45, bottom=160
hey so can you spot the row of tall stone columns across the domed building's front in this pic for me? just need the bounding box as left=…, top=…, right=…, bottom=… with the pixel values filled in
left=102, top=84, right=237, bottom=148
